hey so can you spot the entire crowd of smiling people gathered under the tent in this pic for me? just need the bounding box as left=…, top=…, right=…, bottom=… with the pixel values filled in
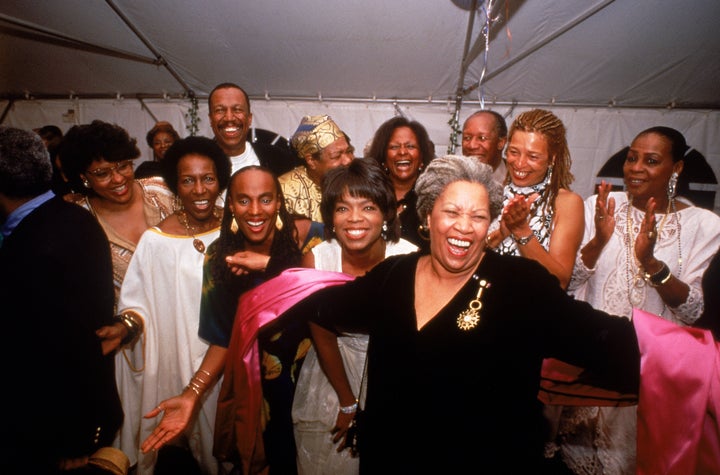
left=0, top=82, right=720, bottom=475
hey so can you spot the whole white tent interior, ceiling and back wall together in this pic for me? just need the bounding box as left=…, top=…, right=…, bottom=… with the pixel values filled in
left=0, top=0, right=720, bottom=212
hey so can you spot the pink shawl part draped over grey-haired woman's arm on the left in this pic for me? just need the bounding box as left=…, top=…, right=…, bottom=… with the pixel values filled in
left=214, top=268, right=354, bottom=474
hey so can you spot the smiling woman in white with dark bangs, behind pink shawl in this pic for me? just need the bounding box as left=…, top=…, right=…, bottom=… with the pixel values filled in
left=292, top=158, right=417, bottom=475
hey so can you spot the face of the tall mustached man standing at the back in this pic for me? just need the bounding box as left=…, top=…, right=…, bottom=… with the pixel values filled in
left=208, top=87, right=252, bottom=157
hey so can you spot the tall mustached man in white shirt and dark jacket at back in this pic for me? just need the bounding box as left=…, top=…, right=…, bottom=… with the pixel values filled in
left=208, top=82, right=299, bottom=176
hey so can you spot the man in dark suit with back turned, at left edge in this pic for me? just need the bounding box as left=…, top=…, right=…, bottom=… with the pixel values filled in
left=0, top=127, right=123, bottom=473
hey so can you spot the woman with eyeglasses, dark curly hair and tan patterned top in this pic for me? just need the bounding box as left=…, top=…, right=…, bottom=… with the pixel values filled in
left=59, top=120, right=174, bottom=320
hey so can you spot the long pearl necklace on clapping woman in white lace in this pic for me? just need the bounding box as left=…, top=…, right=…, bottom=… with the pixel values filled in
left=623, top=197, right=682, bottom=307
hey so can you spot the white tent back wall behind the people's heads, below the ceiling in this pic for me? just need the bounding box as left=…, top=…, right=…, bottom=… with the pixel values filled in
left=0, top=98, right=720, bottom=214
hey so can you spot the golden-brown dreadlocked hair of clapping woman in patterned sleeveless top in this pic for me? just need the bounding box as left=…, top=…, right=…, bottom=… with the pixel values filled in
left=508, top=109, right=575, bottom=213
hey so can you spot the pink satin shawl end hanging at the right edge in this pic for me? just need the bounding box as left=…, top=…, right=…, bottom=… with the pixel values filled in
left=539, top=309, right=720, bottom=475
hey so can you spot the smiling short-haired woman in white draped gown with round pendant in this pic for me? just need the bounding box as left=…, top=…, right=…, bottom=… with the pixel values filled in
left=116, top=137, right=230, bottom=475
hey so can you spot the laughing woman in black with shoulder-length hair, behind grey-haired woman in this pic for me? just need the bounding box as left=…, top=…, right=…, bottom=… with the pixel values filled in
left=365, top=117, right=435, bottom=252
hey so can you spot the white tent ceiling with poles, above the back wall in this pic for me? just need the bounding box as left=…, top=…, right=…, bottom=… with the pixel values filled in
left=0, top=0, right=720, bottom=109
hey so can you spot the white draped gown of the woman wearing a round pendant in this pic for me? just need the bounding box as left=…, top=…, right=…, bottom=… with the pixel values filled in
left=115, top=227, right=220, bottom=475
